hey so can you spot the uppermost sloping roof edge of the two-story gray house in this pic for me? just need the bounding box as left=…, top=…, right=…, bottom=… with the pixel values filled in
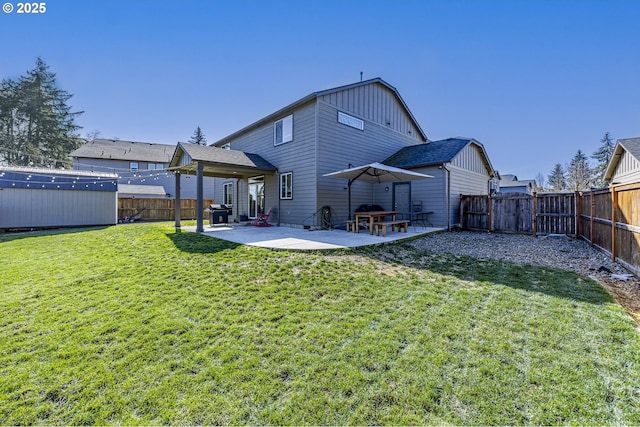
left=212, top=77, right=428, bottom=146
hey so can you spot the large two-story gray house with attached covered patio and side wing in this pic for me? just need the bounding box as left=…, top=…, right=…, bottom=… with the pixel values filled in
left=170, top=78, right=493, bottom=231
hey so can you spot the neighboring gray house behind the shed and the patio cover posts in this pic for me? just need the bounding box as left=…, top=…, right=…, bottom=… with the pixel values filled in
left=70, top=139, right=214, bottom=199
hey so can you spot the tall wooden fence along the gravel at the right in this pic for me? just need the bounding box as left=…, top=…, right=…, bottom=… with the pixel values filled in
left=460, top=183, right=640, bottom=275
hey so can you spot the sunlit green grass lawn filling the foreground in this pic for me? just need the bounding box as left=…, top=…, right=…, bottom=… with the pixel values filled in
left=0, top=223, right=640, bottom=425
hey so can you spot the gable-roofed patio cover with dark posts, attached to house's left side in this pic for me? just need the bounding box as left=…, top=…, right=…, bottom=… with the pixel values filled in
left=169, top=142, right=277, bottom=233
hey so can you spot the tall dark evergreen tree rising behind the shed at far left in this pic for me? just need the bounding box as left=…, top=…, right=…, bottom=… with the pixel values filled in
left=0, top=58, right=82, bottom=167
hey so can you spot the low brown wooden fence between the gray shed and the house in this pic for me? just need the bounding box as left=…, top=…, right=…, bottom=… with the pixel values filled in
left=118, top=198, right=213, bottom=221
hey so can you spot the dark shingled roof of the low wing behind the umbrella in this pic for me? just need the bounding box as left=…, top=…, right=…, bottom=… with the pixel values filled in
left=382, top=137, right=494, bottom=176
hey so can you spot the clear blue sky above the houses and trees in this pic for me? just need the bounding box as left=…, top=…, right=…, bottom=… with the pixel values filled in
left=0, top=0, right=640, bottom=179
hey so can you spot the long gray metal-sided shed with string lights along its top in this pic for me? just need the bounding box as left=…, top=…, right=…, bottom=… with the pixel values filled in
left=0, top=166, right=118, bottom=230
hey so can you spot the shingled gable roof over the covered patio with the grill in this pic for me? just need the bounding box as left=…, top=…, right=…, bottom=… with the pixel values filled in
left=169, top=142, right=277, bottom=178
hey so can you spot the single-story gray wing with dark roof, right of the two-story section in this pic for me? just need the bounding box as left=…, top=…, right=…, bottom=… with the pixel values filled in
left=376, top=137, right=495, bottom=228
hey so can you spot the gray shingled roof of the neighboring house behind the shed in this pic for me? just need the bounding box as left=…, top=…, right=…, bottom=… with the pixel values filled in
left=70, top=138, right=176, bottom=163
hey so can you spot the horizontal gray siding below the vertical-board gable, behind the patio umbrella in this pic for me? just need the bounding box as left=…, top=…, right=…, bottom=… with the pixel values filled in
left=317, top=97, right=416, bottom=223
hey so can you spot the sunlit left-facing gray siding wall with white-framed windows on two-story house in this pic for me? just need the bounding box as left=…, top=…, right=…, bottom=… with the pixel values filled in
left=214, top=102, right=317, bottom=224
